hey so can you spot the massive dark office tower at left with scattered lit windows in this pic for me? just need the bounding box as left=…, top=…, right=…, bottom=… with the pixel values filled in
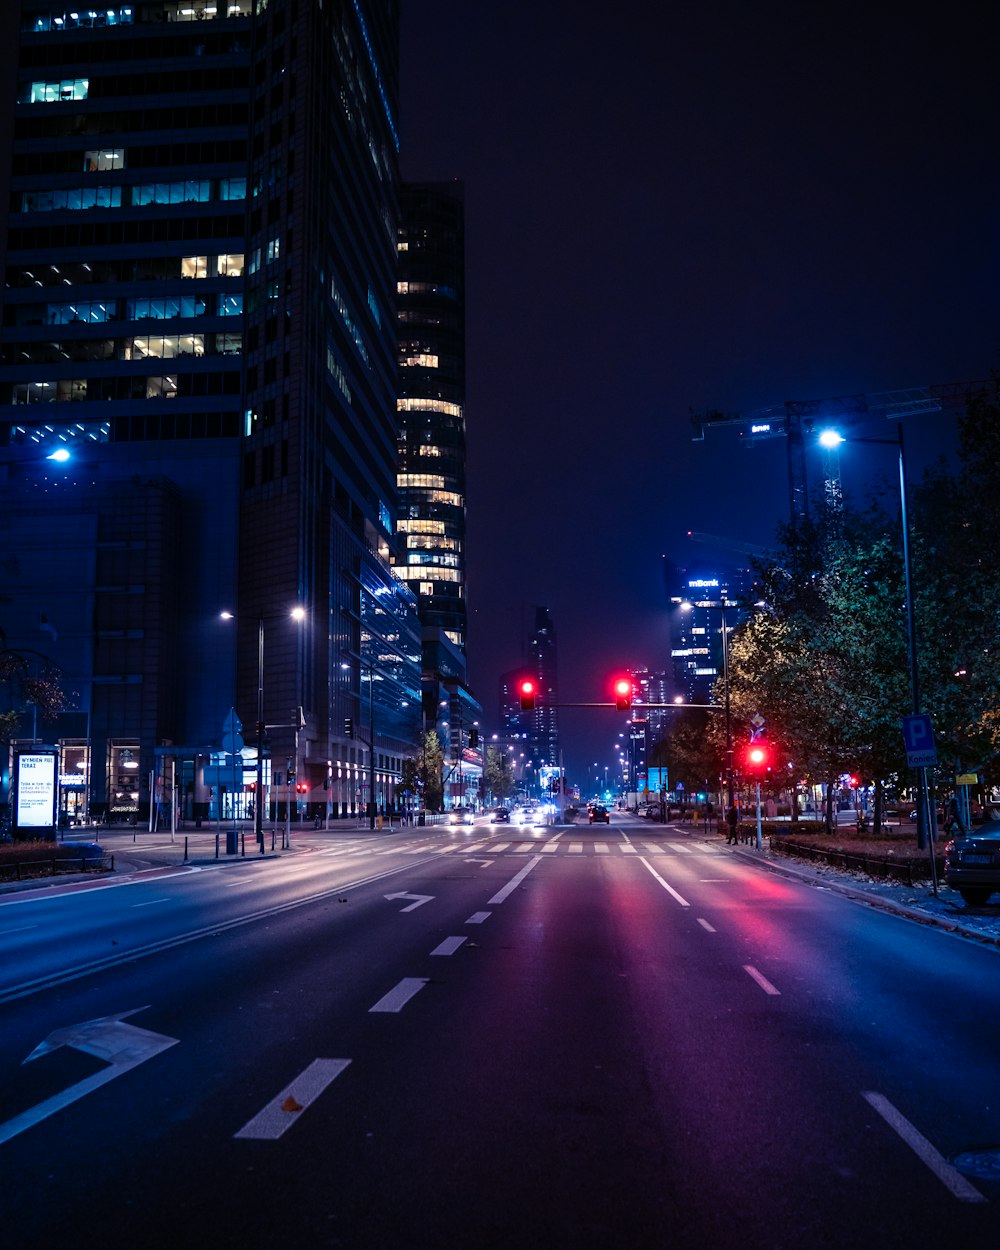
left=0, top=0, right=420, bottom=830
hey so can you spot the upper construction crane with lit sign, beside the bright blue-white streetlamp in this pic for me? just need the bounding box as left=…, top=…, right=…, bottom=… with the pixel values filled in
left=691, top=381, right=985, bottom=521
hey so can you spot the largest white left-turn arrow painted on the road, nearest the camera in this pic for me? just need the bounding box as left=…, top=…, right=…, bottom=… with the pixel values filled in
left=0, top=1008, right=178, bottom=1143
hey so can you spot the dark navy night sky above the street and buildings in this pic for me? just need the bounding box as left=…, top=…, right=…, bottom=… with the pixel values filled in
left=401, top=0, right=1000, bottom=780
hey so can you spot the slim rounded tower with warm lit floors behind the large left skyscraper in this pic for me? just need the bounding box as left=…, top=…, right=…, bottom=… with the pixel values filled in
left=396, top=184, right=466, bottom=651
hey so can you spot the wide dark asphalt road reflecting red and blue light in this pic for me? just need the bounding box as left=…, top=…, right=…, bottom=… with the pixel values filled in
left=0, top=816, right=1000, bottom=1250
